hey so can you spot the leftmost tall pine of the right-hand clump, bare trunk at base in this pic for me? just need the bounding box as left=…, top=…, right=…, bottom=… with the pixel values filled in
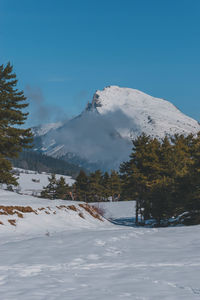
left=120, top=134, right=159, bottom=221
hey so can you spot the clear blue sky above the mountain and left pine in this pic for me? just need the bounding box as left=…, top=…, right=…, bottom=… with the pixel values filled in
left=0, top=0, right=200, bottom=123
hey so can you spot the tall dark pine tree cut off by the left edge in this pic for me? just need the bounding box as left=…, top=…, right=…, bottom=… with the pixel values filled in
left=0, top=63, right=32, bottom=184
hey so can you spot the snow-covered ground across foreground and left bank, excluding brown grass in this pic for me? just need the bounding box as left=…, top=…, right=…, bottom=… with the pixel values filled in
left=0, top=190, right=200, bottom=300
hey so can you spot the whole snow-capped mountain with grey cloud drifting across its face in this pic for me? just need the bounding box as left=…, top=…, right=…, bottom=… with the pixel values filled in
left=34, top=86, right=200, bottom=169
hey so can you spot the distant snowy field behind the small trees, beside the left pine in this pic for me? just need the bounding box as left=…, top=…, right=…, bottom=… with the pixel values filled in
left=14, top=168, right=75, bottom=195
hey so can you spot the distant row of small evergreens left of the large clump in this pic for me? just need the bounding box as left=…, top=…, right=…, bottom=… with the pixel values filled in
left=41, top=170, right=122, bottom=202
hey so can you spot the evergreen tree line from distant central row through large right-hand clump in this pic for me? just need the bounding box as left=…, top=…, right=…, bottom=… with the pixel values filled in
left=41, top=133, right=200, bottom=225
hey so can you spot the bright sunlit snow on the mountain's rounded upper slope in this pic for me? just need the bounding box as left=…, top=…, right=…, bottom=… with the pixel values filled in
left=92, top=86, right=200, bottom=138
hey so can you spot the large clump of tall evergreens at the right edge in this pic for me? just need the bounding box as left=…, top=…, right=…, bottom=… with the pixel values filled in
left=120, top=134, right=200, bottom=225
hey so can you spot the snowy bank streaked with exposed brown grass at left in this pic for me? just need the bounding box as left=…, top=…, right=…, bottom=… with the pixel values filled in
left=0, top=189, right=104, bottom=236
